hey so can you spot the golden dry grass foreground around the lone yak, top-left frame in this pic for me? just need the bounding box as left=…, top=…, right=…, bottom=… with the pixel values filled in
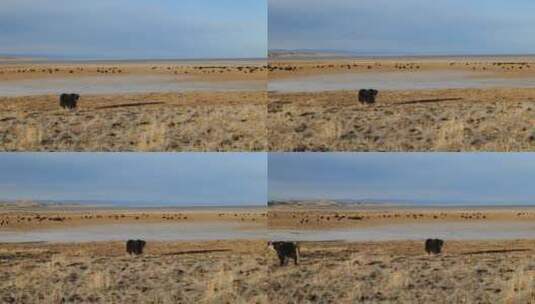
left=0, top=92, right=267, bottom=151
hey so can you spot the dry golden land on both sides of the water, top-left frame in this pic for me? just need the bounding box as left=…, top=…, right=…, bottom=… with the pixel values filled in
left=0, top=62, right=267, bottom=151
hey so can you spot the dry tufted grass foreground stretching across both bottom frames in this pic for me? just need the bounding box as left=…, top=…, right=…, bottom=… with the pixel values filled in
left=0, top=240, right=535, bottom=303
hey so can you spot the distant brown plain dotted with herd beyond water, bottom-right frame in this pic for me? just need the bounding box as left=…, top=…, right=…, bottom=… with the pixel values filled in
left=267, top=201, right=535, bottom=230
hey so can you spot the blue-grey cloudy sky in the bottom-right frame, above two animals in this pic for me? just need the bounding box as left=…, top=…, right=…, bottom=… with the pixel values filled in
left=268, top=153, right=535, bottom=205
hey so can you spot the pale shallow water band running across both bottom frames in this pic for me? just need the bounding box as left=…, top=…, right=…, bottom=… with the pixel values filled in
left=0, top=221, right=535, bottom=243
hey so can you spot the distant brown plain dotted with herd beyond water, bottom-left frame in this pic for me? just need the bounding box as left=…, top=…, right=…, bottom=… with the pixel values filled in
left=0, top=202, right=267, bottom=232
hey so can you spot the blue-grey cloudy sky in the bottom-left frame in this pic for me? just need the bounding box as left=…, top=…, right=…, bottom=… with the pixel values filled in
left=0, top=153, right=267, bottom=206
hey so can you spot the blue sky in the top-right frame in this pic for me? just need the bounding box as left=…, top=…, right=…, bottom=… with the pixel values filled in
left=268, top=0, right=535, bottom=55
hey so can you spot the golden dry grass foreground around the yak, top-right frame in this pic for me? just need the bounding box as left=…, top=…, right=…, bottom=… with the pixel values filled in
left=267, top=89, right=535, bottom=152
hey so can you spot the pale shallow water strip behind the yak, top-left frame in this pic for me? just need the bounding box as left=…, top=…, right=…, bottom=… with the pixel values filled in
left=0, top=75, right=266, bottom=96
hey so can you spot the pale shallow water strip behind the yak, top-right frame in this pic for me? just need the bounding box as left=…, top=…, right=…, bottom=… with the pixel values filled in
left=268, top=71, right=535, bottom=93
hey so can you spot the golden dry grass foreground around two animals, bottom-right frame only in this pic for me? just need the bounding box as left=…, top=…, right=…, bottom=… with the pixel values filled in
left=268, top=241, right=535, bottom=303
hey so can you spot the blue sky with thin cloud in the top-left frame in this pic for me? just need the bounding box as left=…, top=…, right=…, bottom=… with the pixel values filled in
left=0, top=0, right=267, bottom=59
